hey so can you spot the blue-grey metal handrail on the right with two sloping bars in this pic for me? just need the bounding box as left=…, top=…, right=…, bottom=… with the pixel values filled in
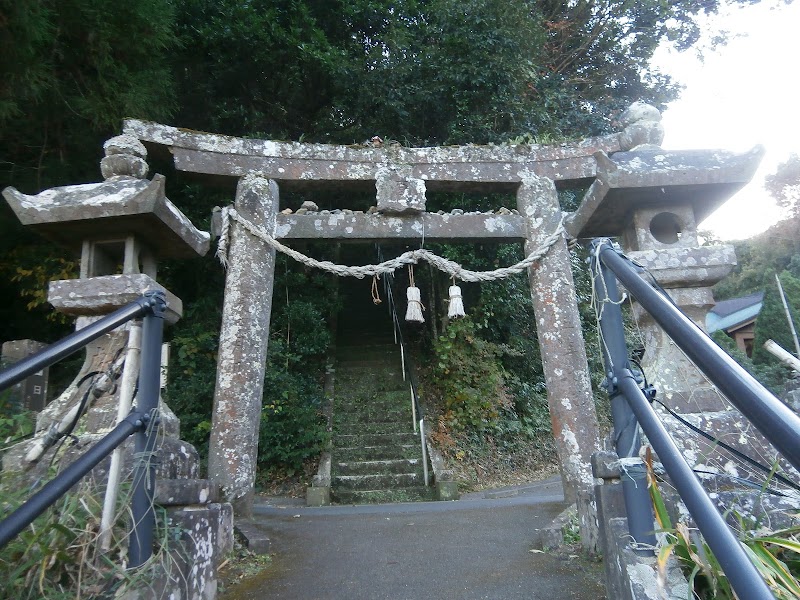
left=591, top=239, right=800, bottom=599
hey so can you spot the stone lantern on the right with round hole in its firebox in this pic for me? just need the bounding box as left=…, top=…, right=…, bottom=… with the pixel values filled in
left=568, top=104, right=788, bottom=476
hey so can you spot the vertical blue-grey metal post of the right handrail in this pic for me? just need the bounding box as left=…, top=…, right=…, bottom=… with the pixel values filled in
left=592, top=240, right=656, bottom=554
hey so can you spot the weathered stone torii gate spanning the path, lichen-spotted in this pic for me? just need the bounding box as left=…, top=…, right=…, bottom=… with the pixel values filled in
left=124, top=103, right=759, bottom=528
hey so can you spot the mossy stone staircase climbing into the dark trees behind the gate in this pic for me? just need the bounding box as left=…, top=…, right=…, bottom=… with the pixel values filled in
left=331, top=278, right=434, bottom=504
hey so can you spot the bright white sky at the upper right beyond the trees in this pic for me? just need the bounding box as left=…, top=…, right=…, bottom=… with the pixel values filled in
left=653, top=0, right=800, bottom=240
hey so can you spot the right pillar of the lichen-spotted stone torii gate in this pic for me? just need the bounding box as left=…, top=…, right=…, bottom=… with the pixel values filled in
left=517, top=177, right=599, bottom=516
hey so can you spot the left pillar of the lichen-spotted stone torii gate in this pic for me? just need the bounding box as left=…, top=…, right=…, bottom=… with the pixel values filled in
left=208, top=174, right=278, bottom=518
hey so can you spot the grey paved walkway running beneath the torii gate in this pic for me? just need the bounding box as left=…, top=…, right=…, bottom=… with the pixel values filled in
left=222, top=477, right=605, bottom=600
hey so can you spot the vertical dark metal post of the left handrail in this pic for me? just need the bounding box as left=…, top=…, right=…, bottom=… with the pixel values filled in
left=128, top=292, right=166, bottom=568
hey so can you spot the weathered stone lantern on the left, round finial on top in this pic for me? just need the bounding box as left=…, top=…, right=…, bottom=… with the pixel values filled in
left=3, top=135, right=210, bottom=477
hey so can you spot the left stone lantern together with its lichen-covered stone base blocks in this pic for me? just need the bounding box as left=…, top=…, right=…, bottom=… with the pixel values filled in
left=3, top=135, right=233, bottom=598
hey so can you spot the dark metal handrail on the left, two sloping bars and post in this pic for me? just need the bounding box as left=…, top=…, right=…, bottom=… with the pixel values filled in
left=0, top=291, right=167, bottom=568
